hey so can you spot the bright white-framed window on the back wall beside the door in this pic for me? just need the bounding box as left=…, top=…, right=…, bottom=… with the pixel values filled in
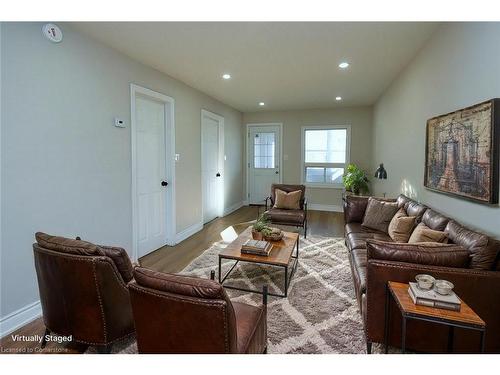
left=302, top=125, right=350, bottom=187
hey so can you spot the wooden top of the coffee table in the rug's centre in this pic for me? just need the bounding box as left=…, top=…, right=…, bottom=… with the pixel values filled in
left=219, top=227, right=299, bottom=266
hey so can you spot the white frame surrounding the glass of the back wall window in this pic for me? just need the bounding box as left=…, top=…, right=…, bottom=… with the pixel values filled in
left=300, top=125, right=351, bottom=189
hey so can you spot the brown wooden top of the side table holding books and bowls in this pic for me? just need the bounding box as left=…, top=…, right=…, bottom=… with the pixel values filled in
left=389, top=281, right=486, bottom=327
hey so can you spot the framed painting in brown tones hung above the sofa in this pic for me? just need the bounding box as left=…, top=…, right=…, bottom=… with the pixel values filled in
left=424, top=99, right=500, bottom=204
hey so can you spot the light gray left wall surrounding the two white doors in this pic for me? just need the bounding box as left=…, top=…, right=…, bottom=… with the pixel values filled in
left=0, top=23, right=243, bottom=316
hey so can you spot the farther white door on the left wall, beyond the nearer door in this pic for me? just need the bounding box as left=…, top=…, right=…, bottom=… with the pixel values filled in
left=201, top=111, right=224, bottom=223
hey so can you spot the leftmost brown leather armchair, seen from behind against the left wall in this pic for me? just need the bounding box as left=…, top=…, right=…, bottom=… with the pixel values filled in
left=33, top=232, right=135, bottom=353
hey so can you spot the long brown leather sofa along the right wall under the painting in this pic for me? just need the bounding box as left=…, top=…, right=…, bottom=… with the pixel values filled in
left=344, top=195, right=500, bottom=353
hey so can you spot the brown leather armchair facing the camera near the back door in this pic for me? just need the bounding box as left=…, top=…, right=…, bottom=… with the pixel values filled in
left=266, top=184, right=307, bottom=238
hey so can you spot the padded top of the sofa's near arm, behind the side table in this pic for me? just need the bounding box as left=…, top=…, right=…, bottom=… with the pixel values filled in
left=366, top=240, right=469, bottom=268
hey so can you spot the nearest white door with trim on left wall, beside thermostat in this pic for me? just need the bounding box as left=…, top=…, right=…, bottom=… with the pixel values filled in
left=130, top=84, right=175, bottom=260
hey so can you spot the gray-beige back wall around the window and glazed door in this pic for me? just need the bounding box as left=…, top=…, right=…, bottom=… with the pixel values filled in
left=243, top=107, right=372, bottom=206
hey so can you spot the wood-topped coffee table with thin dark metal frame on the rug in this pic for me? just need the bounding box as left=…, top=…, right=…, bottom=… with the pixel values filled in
left=219, top=227, right=299, bottom=298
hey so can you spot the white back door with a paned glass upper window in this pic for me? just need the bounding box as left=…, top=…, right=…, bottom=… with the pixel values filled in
left=247, top=125, right=281, bottom=204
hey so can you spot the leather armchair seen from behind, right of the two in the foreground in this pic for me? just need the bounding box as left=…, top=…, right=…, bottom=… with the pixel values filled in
left=129, top=267, right=267, bottom=353
